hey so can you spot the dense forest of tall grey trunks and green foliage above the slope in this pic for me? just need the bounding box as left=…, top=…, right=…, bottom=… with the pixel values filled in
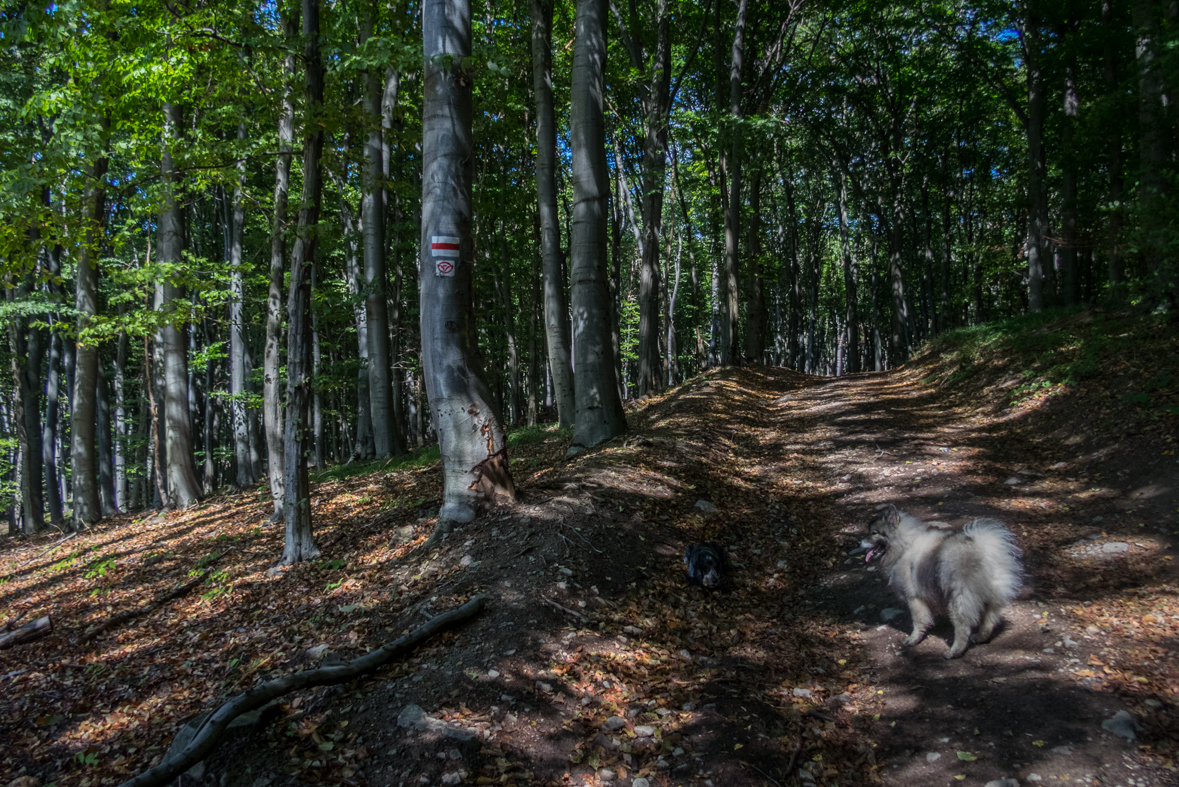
left=0, top=0, right=1179, bottom=551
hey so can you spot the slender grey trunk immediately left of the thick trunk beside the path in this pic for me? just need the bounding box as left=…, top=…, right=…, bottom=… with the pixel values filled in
left=531, top=0, right=577, bottom=428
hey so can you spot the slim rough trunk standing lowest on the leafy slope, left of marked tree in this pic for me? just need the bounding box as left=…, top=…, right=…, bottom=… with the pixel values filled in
left=283, top=0, right=323, bottom=566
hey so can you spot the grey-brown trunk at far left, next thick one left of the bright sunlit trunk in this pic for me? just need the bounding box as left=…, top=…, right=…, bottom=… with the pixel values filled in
left=70, top=143, right=108, bottom=530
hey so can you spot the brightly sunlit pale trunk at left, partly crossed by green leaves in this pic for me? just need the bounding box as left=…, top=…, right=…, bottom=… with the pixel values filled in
left=158, top=104, right=200, bottom=509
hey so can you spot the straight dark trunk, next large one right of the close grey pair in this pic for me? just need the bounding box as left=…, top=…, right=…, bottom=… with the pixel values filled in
left=633, top=0, right=671, bottom=396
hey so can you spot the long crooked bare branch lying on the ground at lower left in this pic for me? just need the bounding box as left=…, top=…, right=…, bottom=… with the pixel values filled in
left=119, top=595, right=487, bottom=787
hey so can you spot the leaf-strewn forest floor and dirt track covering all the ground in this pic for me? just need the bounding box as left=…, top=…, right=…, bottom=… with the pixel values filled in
left=0, top=312, right=1179, bottom=787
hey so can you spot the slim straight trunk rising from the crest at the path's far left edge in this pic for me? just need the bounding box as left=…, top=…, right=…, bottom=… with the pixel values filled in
left=717, top=0, right=749, bottom=365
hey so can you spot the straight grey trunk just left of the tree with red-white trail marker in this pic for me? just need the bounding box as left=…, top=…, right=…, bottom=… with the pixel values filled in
left=360, top=0, right=404, bottom=457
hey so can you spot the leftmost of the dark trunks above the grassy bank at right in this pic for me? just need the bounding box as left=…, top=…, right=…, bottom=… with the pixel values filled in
left=1023, top=10, right=1048, bottom=311
